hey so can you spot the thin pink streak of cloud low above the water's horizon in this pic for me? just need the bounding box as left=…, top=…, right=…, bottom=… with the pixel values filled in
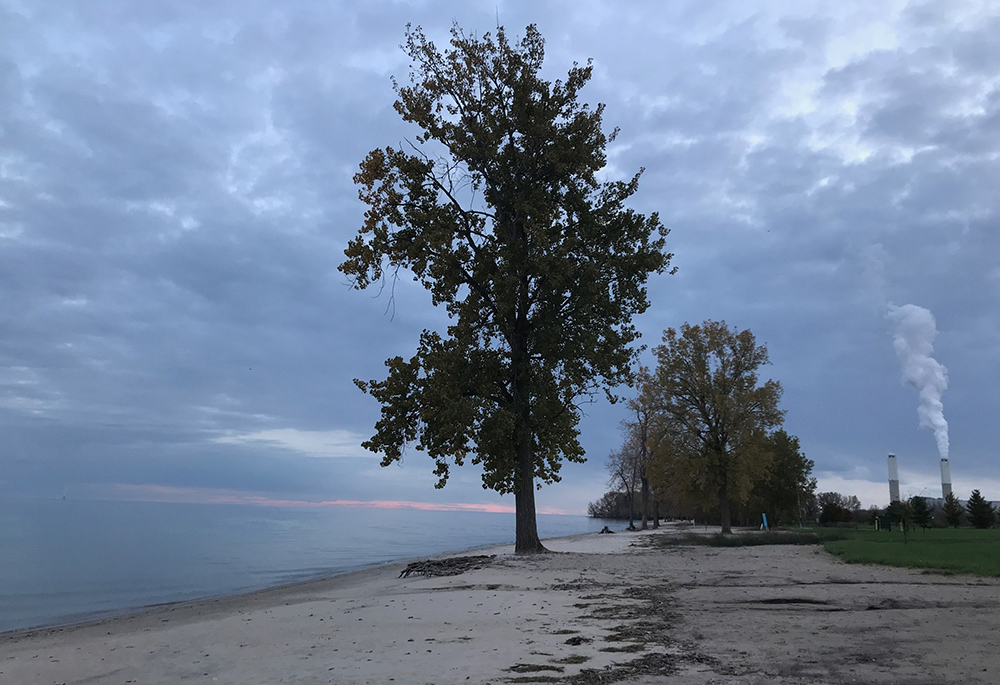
left=102, top=483, right=566, bottom=514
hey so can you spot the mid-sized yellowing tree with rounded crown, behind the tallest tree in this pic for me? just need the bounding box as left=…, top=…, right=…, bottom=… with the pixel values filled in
left=654, top=321, right=784, bottom=533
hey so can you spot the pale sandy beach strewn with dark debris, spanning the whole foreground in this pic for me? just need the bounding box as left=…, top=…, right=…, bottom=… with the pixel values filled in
left=0, top=527, right=1000, bottom=685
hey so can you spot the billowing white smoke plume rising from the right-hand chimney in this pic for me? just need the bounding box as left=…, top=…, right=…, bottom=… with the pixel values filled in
left=887, top=304, right=948, bottom=459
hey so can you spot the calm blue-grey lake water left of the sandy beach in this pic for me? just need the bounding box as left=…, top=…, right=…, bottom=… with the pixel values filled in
left=0, top=500, right=606, bottom=631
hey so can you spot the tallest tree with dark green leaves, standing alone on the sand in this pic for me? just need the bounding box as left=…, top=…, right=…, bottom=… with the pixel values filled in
left=340, top=26, right=671, bottom=552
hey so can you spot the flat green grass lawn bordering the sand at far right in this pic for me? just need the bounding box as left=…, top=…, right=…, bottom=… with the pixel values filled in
left=824, top=528, right=1000, bottom=577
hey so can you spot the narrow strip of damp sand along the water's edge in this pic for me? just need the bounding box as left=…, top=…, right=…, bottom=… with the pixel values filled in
left=0, top=530, right=641, bottom=642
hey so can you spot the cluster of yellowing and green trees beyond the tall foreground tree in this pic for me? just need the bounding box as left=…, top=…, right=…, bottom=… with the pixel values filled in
left=588, top=320, right=816, bottom=533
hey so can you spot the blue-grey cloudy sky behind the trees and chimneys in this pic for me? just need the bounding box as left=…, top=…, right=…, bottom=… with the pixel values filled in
left=0, top=0, right=1000, bottom=513
